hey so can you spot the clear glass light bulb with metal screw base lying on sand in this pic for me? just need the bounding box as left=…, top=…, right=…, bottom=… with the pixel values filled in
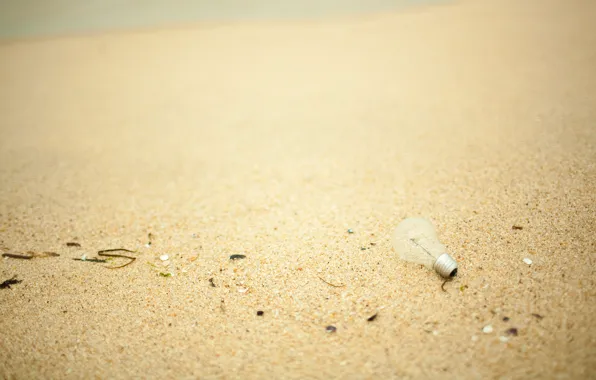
left=392, top=218, right=457, bottom=278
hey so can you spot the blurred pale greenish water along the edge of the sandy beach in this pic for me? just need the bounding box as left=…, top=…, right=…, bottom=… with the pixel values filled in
left=0, top=0, right=436, bottom=38
